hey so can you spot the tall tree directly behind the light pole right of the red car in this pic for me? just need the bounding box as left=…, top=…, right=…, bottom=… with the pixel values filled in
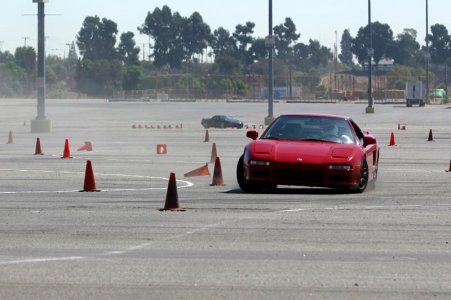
left=351, top=22, right=393, bottom=66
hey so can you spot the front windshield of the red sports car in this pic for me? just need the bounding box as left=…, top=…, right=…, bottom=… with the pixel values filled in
left=261, top=115, right=356, bottom=144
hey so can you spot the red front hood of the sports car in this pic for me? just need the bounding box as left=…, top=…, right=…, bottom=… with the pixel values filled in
left=250, top=140, right=359, bottom=164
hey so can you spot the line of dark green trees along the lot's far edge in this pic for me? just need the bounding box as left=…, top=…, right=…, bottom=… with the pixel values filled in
left=0, top=6, right=451, bottom=97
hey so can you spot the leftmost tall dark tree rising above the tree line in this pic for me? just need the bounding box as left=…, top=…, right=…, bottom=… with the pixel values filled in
left=77, top=16, right=118, bottom=60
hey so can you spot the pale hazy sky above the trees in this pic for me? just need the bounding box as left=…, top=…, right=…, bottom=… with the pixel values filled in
left=0, top=0, right=451, bottom=56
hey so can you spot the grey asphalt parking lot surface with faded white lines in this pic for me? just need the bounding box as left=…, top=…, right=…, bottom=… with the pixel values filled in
left=0, top=99, right=451, bottom=299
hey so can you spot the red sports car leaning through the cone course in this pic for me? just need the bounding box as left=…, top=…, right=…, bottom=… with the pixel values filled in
left=236, top=114, right=379, bottom=193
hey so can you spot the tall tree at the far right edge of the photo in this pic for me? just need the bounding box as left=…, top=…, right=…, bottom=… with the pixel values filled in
left=429, top=24, right=451, bottom=64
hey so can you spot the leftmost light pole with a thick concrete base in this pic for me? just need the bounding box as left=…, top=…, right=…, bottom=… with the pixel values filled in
left=30, top=0, right=52, bottom=132
